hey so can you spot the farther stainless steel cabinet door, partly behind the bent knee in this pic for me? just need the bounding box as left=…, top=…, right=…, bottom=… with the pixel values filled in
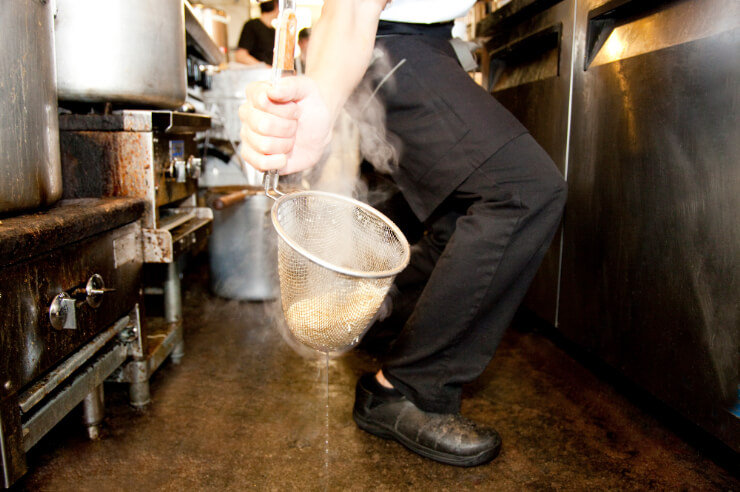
left=483, top=0, right=575, bottom=324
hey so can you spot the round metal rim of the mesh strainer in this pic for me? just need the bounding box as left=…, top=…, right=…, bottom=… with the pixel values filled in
left=270, top=191, right=411, bottom=279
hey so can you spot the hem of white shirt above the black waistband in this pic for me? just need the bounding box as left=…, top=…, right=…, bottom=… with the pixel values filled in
left=380, top=0, right=475, bottom=24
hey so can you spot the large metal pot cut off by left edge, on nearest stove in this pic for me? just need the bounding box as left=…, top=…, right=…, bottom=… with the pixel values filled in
left=0, top=0, right=62, bottom=215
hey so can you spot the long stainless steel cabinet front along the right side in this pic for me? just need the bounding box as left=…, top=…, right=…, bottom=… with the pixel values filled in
left=482, top=0, right=740, bottom=451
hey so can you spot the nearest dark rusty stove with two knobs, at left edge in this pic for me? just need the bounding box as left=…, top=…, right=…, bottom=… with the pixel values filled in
left=0, top=198, right=146, bottom=487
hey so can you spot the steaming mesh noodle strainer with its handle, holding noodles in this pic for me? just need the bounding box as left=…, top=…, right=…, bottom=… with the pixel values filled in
left=264, top=0, right=410, bottom=353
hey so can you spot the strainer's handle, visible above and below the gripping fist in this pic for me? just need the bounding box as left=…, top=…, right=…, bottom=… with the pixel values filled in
left=262, top=0, right=298, bottom=200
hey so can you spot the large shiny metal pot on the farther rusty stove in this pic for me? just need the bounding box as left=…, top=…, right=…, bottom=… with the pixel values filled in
left=55, top=0, right=187, bottom=108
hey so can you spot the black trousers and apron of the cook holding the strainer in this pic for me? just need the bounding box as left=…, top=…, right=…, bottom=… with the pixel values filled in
left=368, top=31, right=566, bottom=413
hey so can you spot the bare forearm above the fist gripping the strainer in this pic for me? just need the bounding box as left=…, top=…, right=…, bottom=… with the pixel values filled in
left=306, top=0, right=387, bottom=121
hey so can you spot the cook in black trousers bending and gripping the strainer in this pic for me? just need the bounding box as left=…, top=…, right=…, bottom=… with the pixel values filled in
left=239, top=0, right=566, bottom=466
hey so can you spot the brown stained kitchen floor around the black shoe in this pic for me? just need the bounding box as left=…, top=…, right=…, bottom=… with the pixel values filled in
left=13, top=258, right=740, bottom=492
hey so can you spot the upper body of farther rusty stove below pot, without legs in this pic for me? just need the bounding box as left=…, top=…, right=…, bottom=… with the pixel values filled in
left=59, top=109, right=213, bottom=263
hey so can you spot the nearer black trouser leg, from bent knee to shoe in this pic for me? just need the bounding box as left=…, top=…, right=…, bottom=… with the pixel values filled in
left=383, top=135, right=565, bottom=413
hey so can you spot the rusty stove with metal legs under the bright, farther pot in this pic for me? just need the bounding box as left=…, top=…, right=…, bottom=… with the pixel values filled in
left=59, top=110, right=213, bottom=406
